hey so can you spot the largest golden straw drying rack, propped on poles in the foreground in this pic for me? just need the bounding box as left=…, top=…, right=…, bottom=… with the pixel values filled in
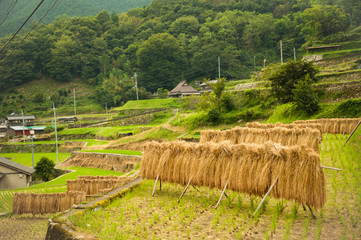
left=140, top=141, right=326, bottom=208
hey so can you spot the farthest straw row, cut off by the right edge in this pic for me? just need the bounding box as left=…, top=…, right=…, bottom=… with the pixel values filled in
left=293, top=118, right=361, bottom=134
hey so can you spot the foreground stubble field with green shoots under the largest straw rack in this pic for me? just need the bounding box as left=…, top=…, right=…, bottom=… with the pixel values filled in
left=70, top=134, right=361, bottom=240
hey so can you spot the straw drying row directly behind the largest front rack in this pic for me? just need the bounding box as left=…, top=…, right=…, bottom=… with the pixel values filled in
left=200, top=127, right=322, bottom=152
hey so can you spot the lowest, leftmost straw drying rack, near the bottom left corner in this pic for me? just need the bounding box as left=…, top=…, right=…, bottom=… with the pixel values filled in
left=13, top=191, right=86, bottom=214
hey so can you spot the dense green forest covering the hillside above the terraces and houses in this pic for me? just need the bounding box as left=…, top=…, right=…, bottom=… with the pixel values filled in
left=0, top=0, right=361, bottom=106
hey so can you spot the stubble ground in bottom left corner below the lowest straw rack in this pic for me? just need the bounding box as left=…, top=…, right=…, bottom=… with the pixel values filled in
left=0, top=214, right=50, bottom=240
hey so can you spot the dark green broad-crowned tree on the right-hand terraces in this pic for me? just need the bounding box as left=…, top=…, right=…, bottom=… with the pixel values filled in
left=264, top=60, right=318, bottom=103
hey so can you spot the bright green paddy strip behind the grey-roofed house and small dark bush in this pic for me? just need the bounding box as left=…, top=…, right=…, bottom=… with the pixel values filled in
left=0, top=153, right=70, bottom=167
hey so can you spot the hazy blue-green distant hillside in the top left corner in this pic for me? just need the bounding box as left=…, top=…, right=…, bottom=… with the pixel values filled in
left=0, top=0, right=151, bottom=37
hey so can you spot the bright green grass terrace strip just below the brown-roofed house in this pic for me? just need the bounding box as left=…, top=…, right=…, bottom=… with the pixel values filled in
left=112, top=98, right=181, bottom=111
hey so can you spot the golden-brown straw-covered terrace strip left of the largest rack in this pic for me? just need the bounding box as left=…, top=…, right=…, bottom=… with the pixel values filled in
left=60, top=152, right=141, bottom=173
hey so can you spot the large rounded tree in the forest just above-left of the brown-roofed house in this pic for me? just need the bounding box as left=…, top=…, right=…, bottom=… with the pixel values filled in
left=137, top=33, right=186, bottom=92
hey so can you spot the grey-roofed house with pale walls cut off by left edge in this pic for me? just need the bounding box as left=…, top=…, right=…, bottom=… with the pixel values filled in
left=0, top=157, right=35, bottom=189
